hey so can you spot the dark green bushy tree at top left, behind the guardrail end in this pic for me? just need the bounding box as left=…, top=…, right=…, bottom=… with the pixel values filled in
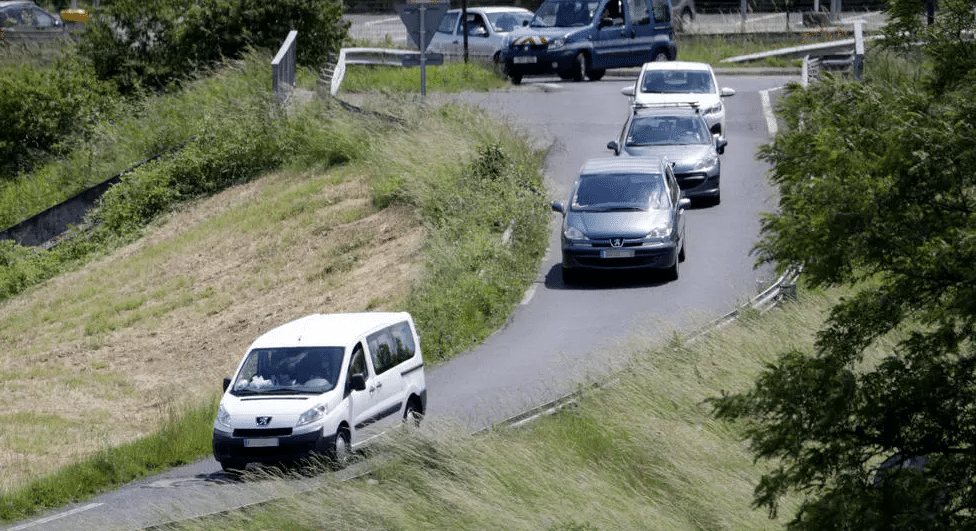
left=79, top=0, right=349, bottom=91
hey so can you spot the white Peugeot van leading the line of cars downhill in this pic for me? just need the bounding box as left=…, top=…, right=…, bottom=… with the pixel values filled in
left=213, top=312, right=427, bottom=471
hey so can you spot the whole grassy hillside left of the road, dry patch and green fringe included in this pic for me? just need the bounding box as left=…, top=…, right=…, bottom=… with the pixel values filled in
left=0, top=59, right=550, bottom=521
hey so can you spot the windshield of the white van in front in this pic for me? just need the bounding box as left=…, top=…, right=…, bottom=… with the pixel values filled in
left=230, top=347, right=345, bottom=396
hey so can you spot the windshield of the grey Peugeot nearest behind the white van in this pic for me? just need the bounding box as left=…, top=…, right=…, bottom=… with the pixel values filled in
left=572, top=174, right=668, bottom=212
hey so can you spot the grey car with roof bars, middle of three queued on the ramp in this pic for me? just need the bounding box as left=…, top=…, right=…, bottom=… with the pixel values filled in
left=607, top=105, right=728, bottom=204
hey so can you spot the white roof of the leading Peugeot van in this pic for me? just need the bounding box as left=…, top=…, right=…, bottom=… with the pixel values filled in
left=248, top=312, right=412, bottom=350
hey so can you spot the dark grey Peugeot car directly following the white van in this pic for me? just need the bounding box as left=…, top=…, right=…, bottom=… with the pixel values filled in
left=552, top=157, right=691, bottom=283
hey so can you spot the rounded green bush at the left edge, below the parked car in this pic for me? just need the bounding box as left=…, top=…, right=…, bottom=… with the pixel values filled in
left=0, top=53, right=118, bottom=180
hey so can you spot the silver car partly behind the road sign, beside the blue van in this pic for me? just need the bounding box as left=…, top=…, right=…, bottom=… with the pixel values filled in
left=427, top=6, right=532, bottom=62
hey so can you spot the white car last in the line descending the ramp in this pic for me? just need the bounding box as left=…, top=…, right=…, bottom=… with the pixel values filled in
left=621, top=61, right=735, bottom=145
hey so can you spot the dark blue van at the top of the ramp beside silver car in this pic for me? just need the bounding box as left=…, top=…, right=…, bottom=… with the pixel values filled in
left=503, top=0, right=678, bottom=85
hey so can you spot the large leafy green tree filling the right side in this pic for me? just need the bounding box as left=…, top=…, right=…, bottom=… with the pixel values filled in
left=711, top=0, right=976, bottom=530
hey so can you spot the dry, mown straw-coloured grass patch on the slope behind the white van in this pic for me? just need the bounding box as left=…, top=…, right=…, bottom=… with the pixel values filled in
left=0, top=169, right=423, bottom=490
